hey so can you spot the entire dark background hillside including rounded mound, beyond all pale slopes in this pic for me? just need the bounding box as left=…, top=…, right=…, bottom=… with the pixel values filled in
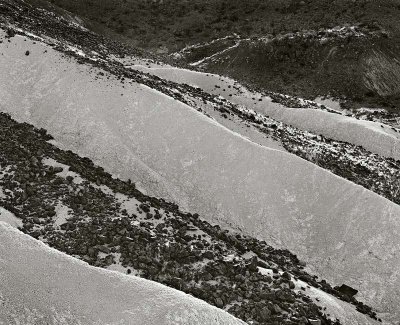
left=30, top=0, right=400, bottom=113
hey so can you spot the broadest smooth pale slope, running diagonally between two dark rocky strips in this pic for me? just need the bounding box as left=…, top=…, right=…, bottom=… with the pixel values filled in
left=0, top=33, right=400, bottom=313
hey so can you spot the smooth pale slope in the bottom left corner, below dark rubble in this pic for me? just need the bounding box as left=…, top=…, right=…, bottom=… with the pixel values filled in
left=0, top=222, right=244, bottom=325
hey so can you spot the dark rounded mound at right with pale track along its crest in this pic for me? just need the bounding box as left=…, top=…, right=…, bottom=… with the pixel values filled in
left=183, top=29, right=400, bottom=112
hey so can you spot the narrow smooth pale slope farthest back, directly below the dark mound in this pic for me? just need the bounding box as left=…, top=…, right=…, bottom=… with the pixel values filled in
left=126, top=60, right=400, bottom=160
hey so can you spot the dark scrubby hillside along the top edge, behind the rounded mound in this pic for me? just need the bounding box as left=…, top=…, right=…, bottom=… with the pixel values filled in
left=29, top=0, right=400, bottom=51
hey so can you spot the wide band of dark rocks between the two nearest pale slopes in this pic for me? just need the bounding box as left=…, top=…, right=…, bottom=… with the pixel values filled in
left=0, top=113, right=377, bottom=325
